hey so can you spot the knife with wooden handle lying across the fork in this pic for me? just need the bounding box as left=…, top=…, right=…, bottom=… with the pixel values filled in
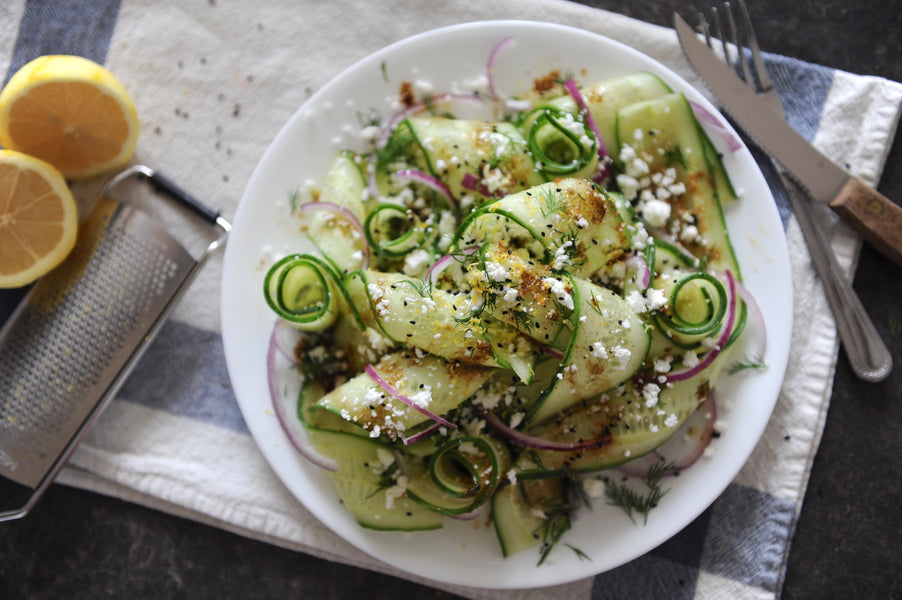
left=673, top=15, right=902, bottom=266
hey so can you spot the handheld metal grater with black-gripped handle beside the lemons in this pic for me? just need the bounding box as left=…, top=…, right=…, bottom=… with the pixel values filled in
left=0, top=165, right=231, bottom=521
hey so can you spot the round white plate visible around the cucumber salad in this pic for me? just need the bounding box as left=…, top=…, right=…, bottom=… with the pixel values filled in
left=222, top=21, right=792, bottom=588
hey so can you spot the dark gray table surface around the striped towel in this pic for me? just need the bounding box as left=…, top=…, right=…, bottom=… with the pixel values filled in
left=0, top=0, right=902, bottom=600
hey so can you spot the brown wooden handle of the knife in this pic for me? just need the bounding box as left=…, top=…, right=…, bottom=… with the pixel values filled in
left=830, top=177, right=902, bottom=267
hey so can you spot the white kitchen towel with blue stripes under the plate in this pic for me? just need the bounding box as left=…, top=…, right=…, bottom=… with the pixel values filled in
left=0, top=0, right=902, bottom=599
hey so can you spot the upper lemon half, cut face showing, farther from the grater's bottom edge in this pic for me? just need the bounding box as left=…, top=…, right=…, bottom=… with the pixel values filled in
left=0, top=55, right=139, bottom=179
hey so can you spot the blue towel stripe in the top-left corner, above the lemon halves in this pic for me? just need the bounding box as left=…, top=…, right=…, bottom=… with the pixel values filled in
left=4, top=0, right=120, bottom=83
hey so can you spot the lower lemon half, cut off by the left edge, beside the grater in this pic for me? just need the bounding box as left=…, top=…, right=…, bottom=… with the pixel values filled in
left=0, top=150, right=78, bottom=288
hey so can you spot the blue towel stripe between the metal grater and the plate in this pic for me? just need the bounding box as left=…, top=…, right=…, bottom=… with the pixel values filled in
left=117, top=320, right=251, bottom=433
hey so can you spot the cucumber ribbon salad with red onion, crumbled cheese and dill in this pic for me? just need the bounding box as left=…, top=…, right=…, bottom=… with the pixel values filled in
left=263, top=39, right=765, bottom=563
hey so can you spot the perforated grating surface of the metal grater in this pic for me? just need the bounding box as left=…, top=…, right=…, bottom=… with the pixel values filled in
left=0, top=206, right=190, bottom=456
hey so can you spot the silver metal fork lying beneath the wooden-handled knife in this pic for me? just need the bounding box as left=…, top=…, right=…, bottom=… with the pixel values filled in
left=698, top=0, right=893, bottom=382
